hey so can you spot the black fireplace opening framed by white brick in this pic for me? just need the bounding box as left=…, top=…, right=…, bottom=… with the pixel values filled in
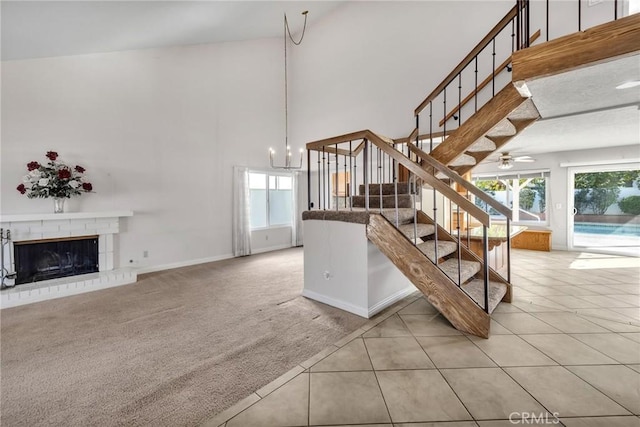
left=14, top=236, right=98, bottom=285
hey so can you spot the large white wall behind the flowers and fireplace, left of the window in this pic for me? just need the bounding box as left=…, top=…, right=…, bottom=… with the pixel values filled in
left=0, top=39, right=290, bottom=266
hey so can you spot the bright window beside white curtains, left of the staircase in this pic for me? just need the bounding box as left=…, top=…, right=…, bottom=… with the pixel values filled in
left=249, top=172, right=293, bottom=229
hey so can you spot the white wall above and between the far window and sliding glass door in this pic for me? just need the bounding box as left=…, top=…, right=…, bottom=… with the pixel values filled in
left=473, top=145, right=640, bottom=250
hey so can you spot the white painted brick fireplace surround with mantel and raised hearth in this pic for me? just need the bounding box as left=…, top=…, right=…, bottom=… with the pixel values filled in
left=0, top=211, right=137, bottom=309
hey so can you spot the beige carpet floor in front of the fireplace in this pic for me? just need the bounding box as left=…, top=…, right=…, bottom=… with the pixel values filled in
left=0, top=249, right=365, bottom=427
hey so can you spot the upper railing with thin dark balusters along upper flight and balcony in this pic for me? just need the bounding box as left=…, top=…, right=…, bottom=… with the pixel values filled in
left=414, top=0, right=628, bottom=152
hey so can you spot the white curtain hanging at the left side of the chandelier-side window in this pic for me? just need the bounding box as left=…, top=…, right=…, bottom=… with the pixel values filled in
left=233, top=166, right=251, bottom=256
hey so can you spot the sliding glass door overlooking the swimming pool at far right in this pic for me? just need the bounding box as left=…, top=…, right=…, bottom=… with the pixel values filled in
left=568, top=164, right=640, bottom=256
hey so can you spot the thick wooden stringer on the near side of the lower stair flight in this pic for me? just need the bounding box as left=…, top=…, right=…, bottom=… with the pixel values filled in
left=367, top=213, right=491, bottom=338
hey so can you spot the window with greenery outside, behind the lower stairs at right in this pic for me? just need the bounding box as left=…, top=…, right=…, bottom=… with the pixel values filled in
left=473, top=171, right=549, bottom=224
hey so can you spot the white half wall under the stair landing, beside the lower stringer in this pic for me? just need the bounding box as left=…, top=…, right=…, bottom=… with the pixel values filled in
left=302, top=220, right=416, bottom=318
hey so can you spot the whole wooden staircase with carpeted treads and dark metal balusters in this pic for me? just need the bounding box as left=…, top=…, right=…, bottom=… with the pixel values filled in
left=307, top=0, right=640, bottom=338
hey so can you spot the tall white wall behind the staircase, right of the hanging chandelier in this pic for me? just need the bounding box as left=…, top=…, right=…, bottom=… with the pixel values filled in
left=290, top=1, right=514, bottom=146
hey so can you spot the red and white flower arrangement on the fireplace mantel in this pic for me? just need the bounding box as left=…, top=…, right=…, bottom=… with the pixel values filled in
left=16, top=151, right=93, bottom=199
